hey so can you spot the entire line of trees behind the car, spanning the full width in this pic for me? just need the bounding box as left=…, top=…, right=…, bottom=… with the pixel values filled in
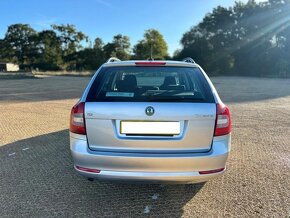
left=0, top=0, right=290, bottom=76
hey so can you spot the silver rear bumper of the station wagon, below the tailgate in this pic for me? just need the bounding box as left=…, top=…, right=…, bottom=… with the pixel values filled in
left=70, top=133, right=231, bottom=183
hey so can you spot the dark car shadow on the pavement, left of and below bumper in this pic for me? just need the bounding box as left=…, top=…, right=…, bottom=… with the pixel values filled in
left=0, top=130, right=204, bottom=217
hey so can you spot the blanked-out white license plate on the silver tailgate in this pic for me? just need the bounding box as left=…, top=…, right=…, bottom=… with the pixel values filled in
left=120, top=121, right=180, bottom=135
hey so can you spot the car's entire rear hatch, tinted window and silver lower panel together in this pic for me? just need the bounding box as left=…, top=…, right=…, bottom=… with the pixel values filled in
left=85, top=66, right=216, bottom=153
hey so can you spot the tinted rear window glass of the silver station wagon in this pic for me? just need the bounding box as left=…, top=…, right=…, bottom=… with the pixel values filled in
left=87, top=66, right=214, bottom=103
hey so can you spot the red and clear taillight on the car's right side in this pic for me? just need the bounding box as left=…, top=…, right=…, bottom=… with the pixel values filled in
left=214, top=103, right=232, bottom=136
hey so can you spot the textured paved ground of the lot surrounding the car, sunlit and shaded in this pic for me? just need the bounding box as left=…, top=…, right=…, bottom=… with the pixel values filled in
left=0, top=77, right=290, bottom=217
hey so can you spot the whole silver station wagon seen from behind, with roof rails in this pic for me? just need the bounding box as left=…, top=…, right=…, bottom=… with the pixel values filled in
left=70, top=58, right=231, bottom=183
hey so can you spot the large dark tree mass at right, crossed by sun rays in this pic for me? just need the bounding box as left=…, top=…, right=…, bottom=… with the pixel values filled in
left=174, top=0, right=290, bottom=76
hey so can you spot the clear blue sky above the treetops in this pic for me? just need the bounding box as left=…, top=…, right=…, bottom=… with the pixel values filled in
left=0, top=0, right=256, bottom=54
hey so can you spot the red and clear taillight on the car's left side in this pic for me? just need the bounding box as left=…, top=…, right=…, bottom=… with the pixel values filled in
left=69, top=102, right=86, bottom=135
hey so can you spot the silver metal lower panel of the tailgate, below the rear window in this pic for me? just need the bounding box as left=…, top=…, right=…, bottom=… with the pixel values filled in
left=85, top=102, right=216, bottom=153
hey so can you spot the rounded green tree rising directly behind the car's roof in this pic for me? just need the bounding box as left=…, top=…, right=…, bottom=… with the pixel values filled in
left=133, top=29, right=168, bottom=59
